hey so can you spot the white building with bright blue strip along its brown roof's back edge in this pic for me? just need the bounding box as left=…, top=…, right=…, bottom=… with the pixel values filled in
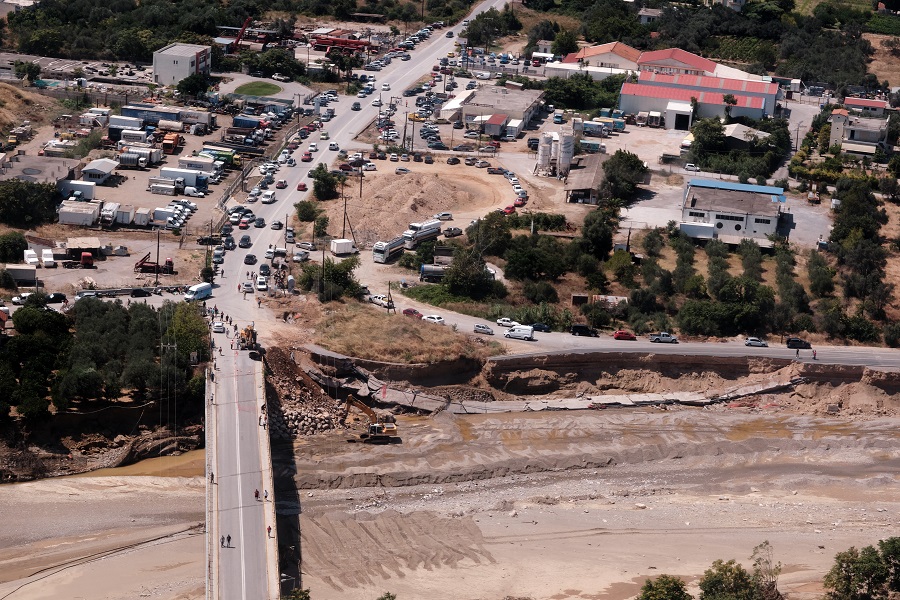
left=680, top=179, right=785, bottom=247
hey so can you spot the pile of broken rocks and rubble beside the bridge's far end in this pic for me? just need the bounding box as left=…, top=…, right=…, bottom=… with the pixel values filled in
left=266, top=348, right=343, bottom=440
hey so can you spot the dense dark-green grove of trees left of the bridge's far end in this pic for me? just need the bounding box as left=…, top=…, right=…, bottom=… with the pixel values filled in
left=0, top=293, right=209, bottom=422
